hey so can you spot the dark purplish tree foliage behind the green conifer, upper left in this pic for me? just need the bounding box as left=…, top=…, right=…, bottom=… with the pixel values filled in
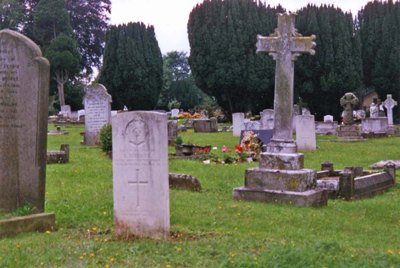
left=8, top=0, right=111, bottom=75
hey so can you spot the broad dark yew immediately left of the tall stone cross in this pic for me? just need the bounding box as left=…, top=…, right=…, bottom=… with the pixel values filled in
left=188, top=0, right=283, bottom=117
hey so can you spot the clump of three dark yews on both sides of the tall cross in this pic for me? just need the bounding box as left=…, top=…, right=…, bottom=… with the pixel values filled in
left=188, top=0, right=400, bottom=119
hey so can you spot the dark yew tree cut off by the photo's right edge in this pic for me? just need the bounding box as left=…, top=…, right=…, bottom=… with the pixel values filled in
left=357, top=0, right=400, bottom=104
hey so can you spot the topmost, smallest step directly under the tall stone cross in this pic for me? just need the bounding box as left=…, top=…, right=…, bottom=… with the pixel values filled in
left=260, top=153, right=304, bottom=170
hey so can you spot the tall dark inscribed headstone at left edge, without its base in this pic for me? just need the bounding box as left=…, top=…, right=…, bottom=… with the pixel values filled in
left=0, top=30, right=50, bottom=211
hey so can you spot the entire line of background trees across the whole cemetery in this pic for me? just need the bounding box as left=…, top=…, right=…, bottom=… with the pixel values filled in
left=0, top=0, right=400, bottom=119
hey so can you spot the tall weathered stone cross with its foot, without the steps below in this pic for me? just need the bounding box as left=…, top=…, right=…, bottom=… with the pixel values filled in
left=257, top=13, right=315, bottom=153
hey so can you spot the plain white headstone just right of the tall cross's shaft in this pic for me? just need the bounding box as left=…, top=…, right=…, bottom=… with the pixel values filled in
left=295, top=115, right=317, bottom=151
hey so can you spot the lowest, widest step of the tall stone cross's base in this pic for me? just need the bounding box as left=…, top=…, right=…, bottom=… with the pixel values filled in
left=233, top=187, right=328, bottom=207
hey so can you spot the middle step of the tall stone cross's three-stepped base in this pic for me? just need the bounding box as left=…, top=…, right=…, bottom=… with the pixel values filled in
left=244, top=168, right=316, bottom=192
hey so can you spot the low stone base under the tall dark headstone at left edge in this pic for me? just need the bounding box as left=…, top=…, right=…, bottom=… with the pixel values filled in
left=0, top=213, right=56, bottom=238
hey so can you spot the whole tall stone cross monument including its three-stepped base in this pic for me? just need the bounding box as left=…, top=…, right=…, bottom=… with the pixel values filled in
left=233, top=14, right=327, bottom=206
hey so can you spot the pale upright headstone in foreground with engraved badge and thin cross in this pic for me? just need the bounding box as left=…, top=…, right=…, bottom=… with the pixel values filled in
left=112, top=112, right=169, bottom=238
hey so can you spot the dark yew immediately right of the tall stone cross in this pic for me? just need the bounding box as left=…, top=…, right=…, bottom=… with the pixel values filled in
left=295, top=5, right=362, bottom=119
